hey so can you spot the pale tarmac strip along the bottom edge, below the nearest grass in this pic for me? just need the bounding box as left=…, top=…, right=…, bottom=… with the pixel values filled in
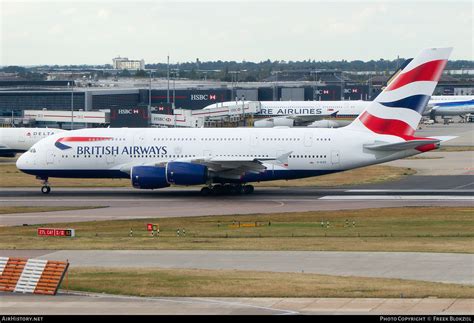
left=0, top=291, right=474, bottom=316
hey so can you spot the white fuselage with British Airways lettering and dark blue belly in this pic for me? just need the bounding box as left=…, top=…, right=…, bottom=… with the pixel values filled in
left=17, top=128, right=419, bottom=182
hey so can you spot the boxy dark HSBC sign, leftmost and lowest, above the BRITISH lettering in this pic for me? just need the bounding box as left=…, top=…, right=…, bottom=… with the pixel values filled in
left=110, top=107, right=150, bottom=128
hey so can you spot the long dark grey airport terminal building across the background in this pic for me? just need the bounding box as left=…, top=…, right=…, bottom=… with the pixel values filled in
left=0, top=78, right=474, bottom=127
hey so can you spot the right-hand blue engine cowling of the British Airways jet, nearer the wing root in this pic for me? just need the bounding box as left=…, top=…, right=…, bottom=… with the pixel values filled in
left=166, top=162, right=208, bottom=185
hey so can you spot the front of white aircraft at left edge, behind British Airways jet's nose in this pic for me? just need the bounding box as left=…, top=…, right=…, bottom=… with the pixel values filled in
left=0, top=128, right=64, bottom=157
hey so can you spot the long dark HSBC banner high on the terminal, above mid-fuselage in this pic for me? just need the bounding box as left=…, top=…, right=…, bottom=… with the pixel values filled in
left=151, top=89, right=231, bottom=110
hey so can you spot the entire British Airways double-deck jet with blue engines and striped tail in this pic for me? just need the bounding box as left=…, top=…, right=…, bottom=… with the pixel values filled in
left=17, top=48, right=452, bottom=194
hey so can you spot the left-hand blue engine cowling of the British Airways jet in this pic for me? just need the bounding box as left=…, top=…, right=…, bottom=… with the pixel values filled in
left=130, top=166, right=170, bottom=189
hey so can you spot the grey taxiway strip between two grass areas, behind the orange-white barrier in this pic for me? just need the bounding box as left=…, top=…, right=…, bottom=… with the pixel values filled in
left=0, top=251, right=474, bottom=285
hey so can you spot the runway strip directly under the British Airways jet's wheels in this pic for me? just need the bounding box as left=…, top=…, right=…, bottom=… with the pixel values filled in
left=0, top=186, right=474, bottom=226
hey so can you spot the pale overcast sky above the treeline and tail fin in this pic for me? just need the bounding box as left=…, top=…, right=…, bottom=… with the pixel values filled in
left=0, top=0, right=474, bottom=65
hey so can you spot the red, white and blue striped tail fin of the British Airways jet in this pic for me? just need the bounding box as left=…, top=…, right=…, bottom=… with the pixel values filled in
left=346, top=48, right=452, bottom=140
